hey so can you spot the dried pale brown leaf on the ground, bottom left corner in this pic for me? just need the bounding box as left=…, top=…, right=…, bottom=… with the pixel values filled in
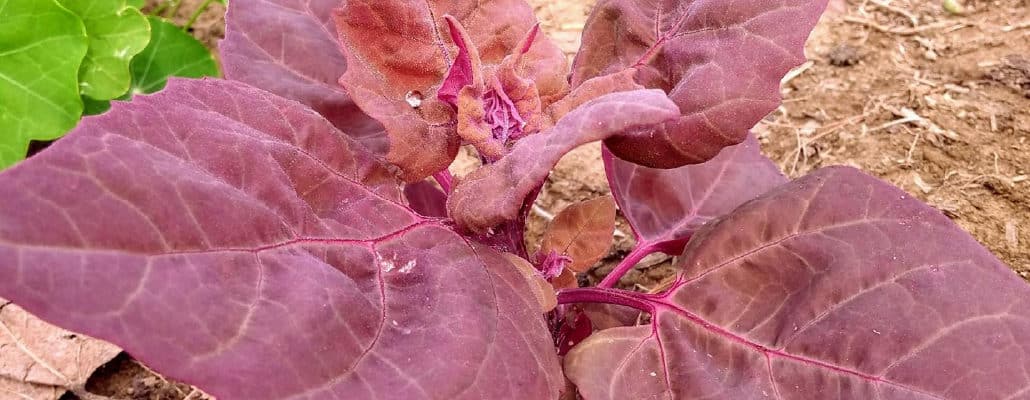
left=0, top=299, right=122, bottom=400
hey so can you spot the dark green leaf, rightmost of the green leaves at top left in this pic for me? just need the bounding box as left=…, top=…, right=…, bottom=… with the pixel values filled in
left=130, top=16, right=218, bottom=94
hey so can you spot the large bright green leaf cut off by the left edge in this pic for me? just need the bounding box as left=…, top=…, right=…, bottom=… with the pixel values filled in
left=0, top=0, right=88, bottom=168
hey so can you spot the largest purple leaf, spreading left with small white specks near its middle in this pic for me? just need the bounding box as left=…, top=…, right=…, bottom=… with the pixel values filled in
left=0, top=80, right=562, bottom=400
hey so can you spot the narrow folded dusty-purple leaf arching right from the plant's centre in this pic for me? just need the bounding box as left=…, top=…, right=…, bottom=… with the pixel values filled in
left=447, top=90, right=679, bottom=233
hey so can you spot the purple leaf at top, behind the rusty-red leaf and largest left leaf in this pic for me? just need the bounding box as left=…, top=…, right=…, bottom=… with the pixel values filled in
left=219, top=0, right=387, bottom=154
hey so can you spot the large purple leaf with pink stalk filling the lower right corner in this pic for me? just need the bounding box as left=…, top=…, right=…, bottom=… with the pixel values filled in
left=565, top=168, right=1030, bottom=400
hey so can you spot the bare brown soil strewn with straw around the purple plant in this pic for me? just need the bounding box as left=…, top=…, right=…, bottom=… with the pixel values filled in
left=38, top=0, right=1030, bottom=400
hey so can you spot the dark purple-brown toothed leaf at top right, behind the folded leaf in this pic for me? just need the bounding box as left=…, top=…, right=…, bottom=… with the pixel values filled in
left=573, top=0, right=826, bottom=168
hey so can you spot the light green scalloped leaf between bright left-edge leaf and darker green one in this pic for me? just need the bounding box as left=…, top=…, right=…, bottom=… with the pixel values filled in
left=61, top=0, right=150, bottom=100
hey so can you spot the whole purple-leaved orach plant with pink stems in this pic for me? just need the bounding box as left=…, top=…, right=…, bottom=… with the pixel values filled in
left=0, top=0, right=1030, bottom=400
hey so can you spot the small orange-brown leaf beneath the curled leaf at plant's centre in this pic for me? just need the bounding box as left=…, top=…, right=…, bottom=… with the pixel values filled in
left=540, top=196, right=615, bottom=272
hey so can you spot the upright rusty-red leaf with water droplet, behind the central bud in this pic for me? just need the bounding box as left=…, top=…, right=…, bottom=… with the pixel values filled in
left=334, top=0, right=568, bottom=181
